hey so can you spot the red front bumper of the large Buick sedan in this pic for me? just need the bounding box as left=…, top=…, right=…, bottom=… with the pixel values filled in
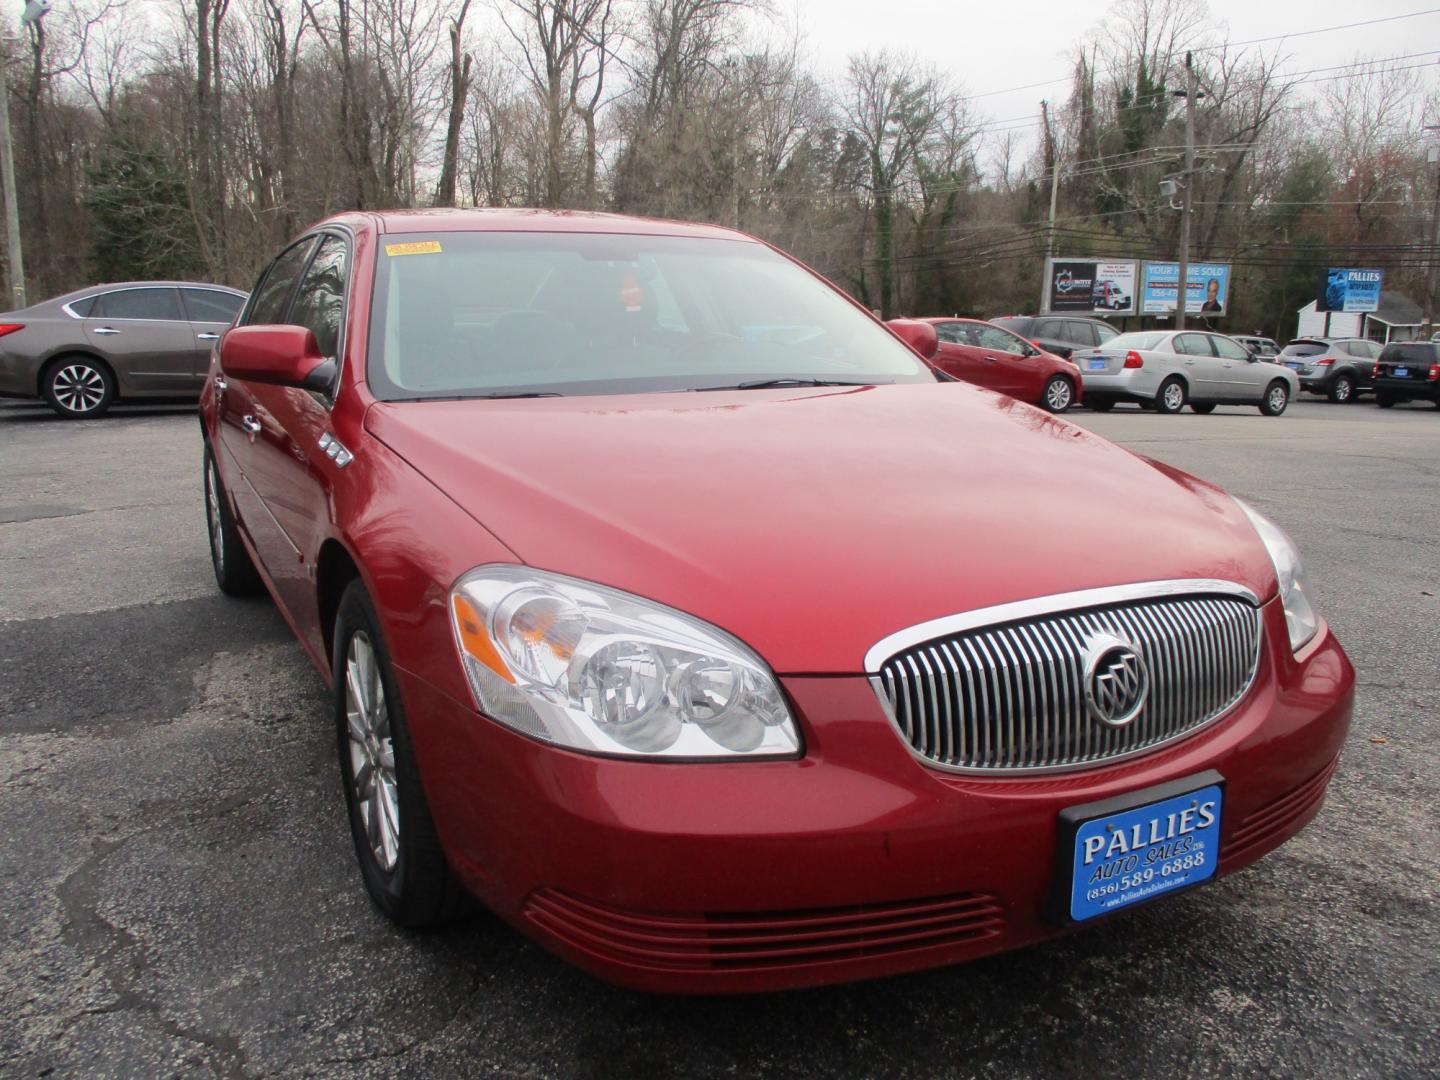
left=400, top=603, right=1354, bottom=992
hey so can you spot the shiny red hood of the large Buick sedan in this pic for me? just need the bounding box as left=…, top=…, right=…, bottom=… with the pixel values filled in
left=366, top=383, right=1274, bottom=674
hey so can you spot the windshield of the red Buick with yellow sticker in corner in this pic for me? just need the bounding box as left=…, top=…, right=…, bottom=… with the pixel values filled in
left=367, top=232, right=937, bottom=400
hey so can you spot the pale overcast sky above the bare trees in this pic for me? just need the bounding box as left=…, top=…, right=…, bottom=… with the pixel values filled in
left=799, top=0, right=1440, bottom=159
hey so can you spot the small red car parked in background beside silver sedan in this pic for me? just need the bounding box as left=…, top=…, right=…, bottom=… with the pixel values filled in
left=923, top=318, right=1084, bottom=412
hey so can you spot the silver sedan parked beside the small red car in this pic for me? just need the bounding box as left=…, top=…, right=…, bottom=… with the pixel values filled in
left=1071, top=330, right=1300, bottom=416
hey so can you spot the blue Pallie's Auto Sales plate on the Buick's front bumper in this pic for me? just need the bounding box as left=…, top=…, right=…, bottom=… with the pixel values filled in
left=1057, top=772, right=1224, bottom=922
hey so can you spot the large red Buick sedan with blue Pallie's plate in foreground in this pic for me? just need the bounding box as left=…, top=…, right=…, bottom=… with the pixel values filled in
left=202, top=210, right=1354, bottom=992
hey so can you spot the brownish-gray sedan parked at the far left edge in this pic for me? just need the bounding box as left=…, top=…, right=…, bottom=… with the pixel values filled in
left=0, top=281, right=245, bottom=419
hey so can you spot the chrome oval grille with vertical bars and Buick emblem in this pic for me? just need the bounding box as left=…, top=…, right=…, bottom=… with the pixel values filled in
left=867, top=582, right=1260, bottom=772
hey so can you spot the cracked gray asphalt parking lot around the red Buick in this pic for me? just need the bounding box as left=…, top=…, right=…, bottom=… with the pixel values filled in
left=0, top=402, right=1440, bottom=1077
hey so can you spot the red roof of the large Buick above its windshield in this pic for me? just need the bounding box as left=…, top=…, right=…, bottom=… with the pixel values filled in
left=323, top=207, right=759, bottom=243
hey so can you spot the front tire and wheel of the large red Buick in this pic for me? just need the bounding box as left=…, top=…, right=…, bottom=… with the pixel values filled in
left=331, top=580, right=464, bottom=927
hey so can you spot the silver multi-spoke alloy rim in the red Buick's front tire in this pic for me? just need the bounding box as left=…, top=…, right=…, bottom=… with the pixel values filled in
left=346, top=631, right=400, bottom=874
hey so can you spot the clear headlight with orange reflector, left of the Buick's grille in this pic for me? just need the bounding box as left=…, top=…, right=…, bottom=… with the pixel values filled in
left=451, top=564, right=801, bottom=757
